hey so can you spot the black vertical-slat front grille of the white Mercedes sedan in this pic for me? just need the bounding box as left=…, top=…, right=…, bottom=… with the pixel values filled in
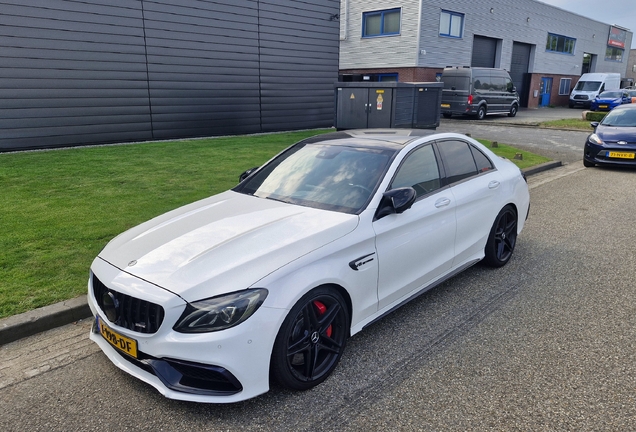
left=93, top=275, right=164, bottom=334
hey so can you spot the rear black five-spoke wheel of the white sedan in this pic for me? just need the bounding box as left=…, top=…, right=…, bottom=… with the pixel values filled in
left=484, top=205, right=518, bottom=267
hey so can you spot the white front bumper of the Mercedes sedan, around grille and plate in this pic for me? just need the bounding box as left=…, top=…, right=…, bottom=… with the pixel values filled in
left=88, top=260, right=287, bottom=403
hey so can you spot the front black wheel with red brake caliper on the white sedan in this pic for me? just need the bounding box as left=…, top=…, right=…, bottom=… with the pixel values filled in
left=271, top=287, right=350, bottom=390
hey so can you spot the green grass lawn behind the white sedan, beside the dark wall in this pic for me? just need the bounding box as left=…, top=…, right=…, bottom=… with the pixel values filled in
left=0, top=130, right=548, bottom=318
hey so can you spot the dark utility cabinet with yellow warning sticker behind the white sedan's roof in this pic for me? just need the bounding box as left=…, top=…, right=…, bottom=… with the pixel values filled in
left=335, top=82, right=444, bottom=129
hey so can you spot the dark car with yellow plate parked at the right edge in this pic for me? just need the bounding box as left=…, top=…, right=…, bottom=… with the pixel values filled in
left=583, top=104, right=636, bottom=167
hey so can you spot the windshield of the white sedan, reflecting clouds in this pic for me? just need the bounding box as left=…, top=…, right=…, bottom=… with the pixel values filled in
left=234, top=143, right=395, bottom=214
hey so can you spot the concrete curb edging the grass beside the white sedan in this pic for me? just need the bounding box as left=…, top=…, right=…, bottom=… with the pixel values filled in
left=0, top=161, right=562, bottom=345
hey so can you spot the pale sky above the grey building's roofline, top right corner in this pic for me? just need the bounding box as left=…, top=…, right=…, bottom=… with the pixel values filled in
left=539, top=0, right=636, bottom=48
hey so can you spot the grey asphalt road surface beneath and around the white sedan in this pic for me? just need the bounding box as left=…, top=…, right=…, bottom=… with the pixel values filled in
left=0, top=116, right=636, bottom=431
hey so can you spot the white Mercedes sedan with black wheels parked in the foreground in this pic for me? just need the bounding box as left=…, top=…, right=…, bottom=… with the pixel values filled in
left=88, top=130, right=530, bottom=403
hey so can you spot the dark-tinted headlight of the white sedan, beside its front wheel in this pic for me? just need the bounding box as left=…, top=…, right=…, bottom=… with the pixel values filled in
left=173, top=288, right=267, bottom=333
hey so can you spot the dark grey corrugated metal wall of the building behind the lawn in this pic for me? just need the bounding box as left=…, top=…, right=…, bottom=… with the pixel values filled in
left=0, top=0, right=339, bottom=151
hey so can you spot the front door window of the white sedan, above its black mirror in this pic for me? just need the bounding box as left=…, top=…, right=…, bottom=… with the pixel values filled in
left=389, top=144, right=440, bottom=197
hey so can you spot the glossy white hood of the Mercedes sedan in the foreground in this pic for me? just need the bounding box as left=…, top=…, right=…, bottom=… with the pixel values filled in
left=99, top=191, right=358, bottom=301
